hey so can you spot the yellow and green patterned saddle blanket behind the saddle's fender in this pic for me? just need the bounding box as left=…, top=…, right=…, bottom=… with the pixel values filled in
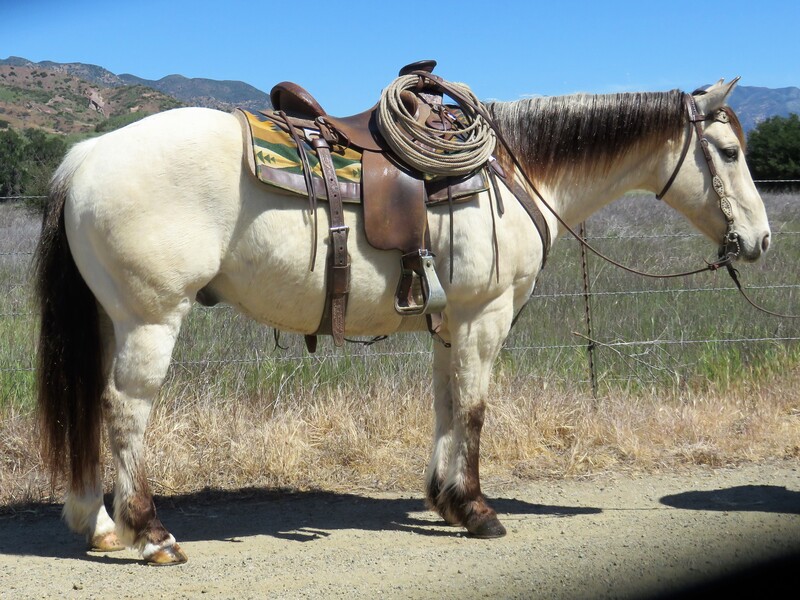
left=236, top=109, right=361, bottom=202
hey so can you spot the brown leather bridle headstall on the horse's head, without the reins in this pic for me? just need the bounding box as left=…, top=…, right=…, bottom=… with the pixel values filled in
left=656, top=94, right=741, bottom=268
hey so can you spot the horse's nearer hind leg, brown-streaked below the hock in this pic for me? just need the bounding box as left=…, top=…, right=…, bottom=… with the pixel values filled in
left=103, top=314, right=189, bottom=564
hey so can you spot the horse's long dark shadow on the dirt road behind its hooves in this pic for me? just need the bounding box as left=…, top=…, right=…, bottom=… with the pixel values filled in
left=0, top=488, right=602, bottom=562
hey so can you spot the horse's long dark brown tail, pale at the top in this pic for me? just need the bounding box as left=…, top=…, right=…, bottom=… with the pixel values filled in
left=34, top=142, right=104, bottom=490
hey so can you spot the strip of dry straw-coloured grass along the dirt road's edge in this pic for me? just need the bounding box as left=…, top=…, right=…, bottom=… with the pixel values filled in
left=0, top=368, right=800, bottom=505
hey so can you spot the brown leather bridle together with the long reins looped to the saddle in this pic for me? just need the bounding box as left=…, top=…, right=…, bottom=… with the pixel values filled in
left=411, top=71, right=800, bottom=321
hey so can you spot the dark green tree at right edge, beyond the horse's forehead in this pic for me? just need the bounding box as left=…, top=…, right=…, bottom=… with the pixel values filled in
left=747, top=114, right=800, bottom=179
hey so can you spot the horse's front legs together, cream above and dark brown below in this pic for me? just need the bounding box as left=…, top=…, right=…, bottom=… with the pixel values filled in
left=428, top=293, right=512, bottom=538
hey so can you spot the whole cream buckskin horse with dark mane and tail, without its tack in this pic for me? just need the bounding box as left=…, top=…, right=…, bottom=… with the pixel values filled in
left=35, top=80, right=770, bottom=564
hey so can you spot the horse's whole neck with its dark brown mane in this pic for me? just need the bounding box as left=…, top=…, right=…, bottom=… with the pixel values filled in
left=492, top=92, right=682, bottom=238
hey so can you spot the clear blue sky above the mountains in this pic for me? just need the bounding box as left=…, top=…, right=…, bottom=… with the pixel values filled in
left=0, top=0, right=800, bottom=115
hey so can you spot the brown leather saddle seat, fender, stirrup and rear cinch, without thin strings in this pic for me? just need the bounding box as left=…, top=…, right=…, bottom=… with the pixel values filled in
left=270, top=61, right=454, bottom=351
